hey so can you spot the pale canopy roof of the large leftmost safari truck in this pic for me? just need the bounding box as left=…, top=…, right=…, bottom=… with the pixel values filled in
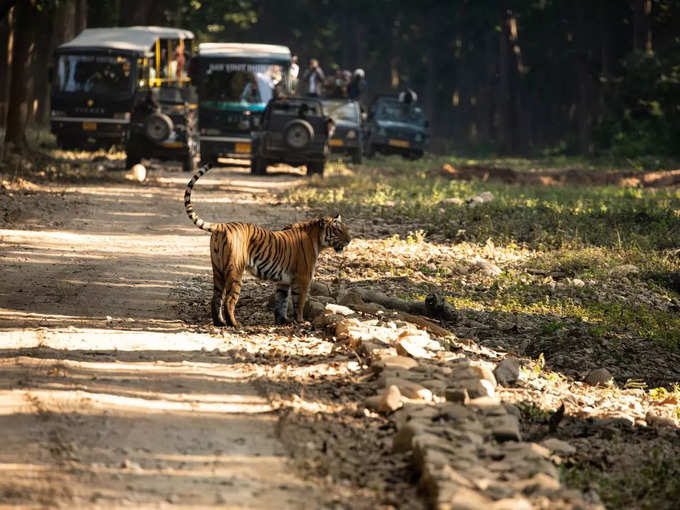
left=57, top=26, right=194, bottom=55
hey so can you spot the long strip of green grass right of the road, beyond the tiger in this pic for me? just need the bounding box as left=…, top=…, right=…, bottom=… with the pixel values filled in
left=288, top=160, right=680, bottom=250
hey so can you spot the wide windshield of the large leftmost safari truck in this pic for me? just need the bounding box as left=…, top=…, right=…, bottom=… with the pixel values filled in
left=54, top=54, right=134, bottom=98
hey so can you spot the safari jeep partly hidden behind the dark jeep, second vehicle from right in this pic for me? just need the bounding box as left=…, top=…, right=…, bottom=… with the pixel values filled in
left=323, top=99, right=364, bottom=164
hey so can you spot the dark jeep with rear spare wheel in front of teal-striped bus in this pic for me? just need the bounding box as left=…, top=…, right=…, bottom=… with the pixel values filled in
left=250, top=97, right=334, bottom=175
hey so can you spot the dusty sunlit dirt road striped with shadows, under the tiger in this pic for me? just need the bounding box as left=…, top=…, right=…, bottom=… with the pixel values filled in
left=0, top=165, right=421, bottom=509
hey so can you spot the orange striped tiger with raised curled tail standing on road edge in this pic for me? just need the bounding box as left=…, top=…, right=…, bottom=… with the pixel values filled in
left=184, top=164, right=351, bottom=328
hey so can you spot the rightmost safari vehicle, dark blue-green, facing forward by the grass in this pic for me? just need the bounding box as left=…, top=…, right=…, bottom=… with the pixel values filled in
left=365, top=96, right=429, bottom=158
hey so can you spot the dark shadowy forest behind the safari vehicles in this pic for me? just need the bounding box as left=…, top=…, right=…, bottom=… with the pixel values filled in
left=0, top=0, right=680, bottom=159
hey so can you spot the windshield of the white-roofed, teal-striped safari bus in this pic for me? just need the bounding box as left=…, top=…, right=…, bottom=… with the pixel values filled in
left=198, top=62, right=283, bottom=107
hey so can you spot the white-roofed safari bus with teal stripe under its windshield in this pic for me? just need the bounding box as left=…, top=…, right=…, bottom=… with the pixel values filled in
left=191, top=43, right=291, bottom=164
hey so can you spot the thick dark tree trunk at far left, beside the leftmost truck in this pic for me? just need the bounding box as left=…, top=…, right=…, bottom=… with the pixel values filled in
left=5, top=0, right=41, bottom=151
